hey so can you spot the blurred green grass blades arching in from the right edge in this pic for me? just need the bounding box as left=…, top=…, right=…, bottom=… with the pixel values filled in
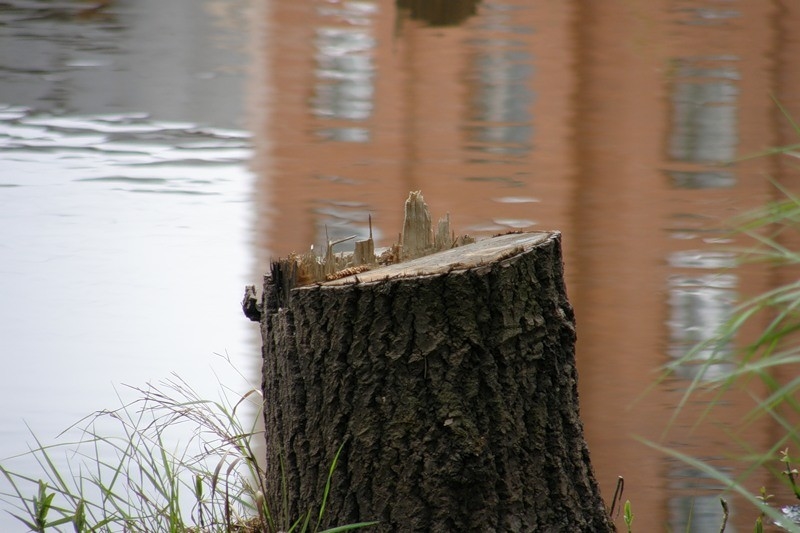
left=648, top=103, right=800, bottom=531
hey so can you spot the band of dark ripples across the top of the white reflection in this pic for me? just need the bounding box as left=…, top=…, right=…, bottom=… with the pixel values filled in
left=0, top=105, right=251, bottom=195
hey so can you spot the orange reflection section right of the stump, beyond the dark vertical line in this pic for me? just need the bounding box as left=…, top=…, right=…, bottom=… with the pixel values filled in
left=570, top=1, right=792, bottom=531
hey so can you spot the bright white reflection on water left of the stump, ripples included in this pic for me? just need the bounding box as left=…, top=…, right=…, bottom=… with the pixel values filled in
left=0, top=105, right=257, bottom=446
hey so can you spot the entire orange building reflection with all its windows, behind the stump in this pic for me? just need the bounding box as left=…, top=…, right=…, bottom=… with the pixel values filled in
left=253, top=0, right=800, bottom=530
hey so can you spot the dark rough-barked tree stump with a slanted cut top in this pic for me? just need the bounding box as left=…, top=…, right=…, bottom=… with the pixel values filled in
left=245, top=232, right=614, bottom=533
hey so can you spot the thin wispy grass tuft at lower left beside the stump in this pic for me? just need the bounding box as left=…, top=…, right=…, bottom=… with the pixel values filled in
left=0, top=375, right=372, bottom=533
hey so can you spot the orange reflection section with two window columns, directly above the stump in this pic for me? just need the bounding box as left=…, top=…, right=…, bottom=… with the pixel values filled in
left=254, top=2, right=571, bottom=262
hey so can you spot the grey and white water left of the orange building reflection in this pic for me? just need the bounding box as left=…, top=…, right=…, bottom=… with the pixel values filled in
left=0, top=1, right=258, bottom=531
